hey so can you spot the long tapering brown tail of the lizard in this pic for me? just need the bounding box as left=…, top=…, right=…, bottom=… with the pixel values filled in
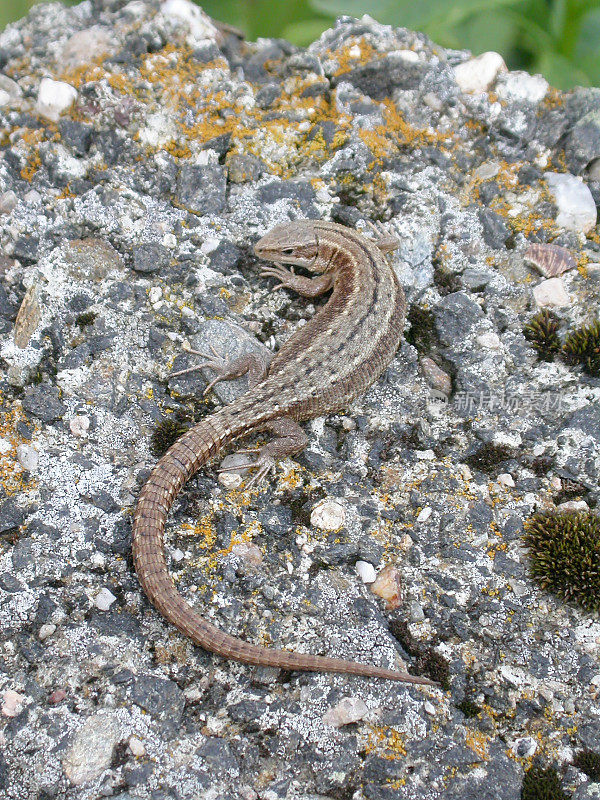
left=132, top=409, right=437, bottom=686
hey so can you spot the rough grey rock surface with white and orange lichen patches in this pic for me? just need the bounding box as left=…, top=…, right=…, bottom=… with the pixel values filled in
left=0, top=0, right=600, bottom=800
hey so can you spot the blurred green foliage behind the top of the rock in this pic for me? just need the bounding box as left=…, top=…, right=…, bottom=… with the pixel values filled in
left=0, top=0, right=600, bottom=89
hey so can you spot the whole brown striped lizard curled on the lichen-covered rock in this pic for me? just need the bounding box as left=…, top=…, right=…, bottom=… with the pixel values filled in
left=132, top=220, right=437, bottom=685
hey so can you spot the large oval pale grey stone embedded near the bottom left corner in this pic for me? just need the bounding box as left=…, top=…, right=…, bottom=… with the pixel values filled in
left=63, top=713, right=120, bottom=786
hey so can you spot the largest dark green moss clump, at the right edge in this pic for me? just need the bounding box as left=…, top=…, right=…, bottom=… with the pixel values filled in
left=523, top=511, right=600, bottom=612
